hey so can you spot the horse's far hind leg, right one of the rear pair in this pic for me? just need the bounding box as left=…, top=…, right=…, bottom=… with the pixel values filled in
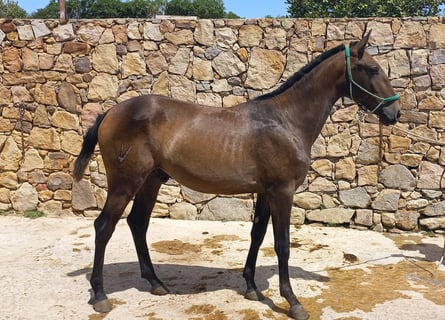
left=127, top=171, right=169, bottom=295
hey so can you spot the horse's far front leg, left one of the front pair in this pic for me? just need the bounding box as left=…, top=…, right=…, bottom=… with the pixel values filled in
left=243, top=194, right=270, bottom=300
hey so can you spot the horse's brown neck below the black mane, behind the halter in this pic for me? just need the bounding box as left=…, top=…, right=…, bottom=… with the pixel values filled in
left=280, top=56, right=346, bottom=142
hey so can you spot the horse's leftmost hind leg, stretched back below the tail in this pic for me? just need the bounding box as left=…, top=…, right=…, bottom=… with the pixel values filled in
left=90, top=183, right=136, bottom=312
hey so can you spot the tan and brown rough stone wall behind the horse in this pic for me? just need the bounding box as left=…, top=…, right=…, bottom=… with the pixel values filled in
left=0, top=18, right=445, bottom=230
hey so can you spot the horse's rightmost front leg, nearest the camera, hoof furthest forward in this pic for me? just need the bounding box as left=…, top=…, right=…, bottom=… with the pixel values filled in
left=268, top=186, right=309, bottom=320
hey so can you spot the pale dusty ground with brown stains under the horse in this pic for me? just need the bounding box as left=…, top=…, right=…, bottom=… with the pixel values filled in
left=0, top=216, right=445, bottom=320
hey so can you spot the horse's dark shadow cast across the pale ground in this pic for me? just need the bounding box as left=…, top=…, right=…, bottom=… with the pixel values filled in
left=68, top=262, right=330, bottom=302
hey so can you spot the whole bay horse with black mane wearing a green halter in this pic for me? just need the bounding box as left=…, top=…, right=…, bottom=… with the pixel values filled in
left=73, top=33, right=400, bottom=320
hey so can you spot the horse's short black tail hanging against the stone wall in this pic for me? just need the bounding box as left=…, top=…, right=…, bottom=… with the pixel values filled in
left=73, top=112, right=106, bottom=181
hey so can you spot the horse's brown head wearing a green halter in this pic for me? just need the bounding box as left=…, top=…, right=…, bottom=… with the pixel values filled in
left=345, top=32, right=400, bottom=124
